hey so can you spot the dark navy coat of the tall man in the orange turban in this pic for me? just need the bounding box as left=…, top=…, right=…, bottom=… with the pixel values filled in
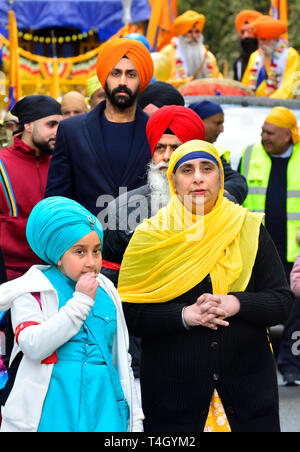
left=45, top=102, right=151, bottom=215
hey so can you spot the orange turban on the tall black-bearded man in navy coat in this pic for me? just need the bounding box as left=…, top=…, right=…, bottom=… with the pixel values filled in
left=96, top=38, right=154, bottom=92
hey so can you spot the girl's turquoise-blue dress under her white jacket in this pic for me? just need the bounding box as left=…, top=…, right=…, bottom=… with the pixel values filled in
left=37, top=266, right=129, bottom=432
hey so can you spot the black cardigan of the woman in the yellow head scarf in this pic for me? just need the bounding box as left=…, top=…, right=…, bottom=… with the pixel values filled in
left=123, top=227, right=294, bottom=432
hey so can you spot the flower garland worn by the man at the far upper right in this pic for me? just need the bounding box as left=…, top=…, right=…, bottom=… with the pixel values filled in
left=249, top=39, right=288, bottom=96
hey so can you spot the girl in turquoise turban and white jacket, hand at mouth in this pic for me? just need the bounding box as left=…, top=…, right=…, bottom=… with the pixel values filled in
left=0, top=197, right=143, bottom=432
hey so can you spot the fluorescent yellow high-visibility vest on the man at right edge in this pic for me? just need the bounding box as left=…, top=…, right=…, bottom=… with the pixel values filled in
left=240, top=142, right=300, bottom=262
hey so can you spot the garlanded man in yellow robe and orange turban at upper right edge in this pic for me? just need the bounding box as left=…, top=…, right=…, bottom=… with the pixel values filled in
left=242, top=15, right=300, bottom=99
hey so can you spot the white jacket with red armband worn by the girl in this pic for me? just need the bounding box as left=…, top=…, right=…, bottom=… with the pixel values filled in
left=0, top=265, right=144, bottom=432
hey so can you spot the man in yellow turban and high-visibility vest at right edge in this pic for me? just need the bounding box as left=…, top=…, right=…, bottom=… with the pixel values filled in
left=239, top=107, right=300, bottom=384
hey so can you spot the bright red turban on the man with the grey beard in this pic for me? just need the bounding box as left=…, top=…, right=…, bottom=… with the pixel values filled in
left=146, top=105, right=205, bottom=155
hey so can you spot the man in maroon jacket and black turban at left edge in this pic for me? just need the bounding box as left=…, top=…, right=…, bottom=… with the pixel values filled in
left=0, top=95, right=62, bottom=280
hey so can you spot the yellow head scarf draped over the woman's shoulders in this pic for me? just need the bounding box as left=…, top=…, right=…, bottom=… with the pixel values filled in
left=118, top=140, right=263, bottom=303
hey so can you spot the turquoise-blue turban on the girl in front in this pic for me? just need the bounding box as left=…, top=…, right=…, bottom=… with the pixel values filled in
left=26, top=196, right=103, bottom=265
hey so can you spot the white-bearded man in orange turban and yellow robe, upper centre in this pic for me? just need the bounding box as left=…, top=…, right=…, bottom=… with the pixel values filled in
left=161, top=10, right=222, bottom=79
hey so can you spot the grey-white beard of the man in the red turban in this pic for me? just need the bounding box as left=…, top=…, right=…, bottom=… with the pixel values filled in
left=148, top=162, right=171, bottom=216
